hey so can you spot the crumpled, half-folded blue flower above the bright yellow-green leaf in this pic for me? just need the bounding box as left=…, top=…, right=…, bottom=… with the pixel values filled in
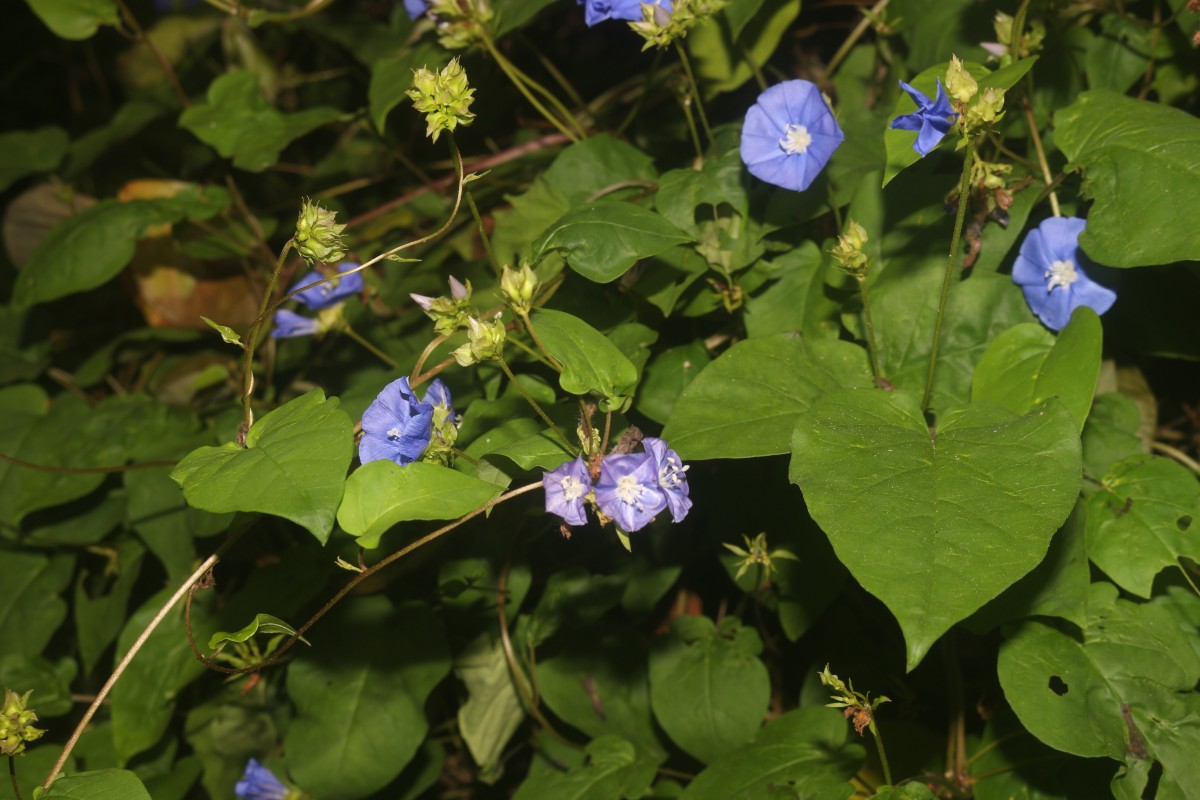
left=359, top=378, right=452, bottom=467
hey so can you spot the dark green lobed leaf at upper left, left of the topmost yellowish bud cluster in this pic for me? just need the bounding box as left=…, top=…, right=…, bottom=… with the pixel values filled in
left=179, top=70, right=342, bottom=173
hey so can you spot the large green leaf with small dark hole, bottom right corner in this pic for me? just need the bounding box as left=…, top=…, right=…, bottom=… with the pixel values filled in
left=997, top=583, right=1200, bottom=798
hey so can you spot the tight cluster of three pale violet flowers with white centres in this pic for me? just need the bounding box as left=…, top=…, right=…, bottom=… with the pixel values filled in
left=541, top=437, right=691, bottom=533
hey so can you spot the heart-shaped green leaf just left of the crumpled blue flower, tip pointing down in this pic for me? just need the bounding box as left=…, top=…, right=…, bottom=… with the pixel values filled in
left=170, top=389, right=354, bottom=545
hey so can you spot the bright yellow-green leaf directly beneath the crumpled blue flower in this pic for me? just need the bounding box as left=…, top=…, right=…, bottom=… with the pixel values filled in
left=337, top=459, right=500, bottom=549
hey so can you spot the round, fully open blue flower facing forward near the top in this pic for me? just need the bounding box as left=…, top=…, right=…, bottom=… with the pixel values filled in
left=742, top=80, right=845, bottom=192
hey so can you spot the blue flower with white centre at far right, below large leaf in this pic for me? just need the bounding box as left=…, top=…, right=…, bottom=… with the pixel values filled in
left=1013, top=217, right=1117, bottom=331
